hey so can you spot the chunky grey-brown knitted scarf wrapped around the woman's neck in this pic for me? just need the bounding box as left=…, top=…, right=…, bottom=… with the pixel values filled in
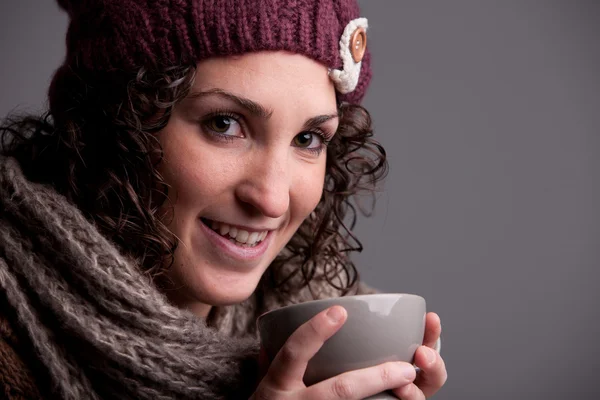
left=0, top=156, right=356, bottom=400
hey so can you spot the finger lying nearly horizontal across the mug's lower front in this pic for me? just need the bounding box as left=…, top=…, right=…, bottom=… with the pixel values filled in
left=307, top=362, right=416, bottom=400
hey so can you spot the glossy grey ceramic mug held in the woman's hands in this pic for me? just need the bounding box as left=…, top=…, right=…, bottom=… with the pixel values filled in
left=257, top=293, right=426, bottom=400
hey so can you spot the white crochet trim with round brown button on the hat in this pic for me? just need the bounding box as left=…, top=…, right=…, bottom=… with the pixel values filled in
left=329, top=18, right=369, bottom=94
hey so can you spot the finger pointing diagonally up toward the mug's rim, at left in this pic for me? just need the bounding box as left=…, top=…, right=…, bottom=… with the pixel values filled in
left=266, top=306, right=348, bottom=390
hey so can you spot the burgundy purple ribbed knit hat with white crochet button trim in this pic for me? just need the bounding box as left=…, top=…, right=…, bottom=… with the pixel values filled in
left=57, top=0, right=371, bottom=103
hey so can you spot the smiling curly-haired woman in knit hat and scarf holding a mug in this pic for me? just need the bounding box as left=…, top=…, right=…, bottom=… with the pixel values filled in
left=0, top=0, right=446, bottom=400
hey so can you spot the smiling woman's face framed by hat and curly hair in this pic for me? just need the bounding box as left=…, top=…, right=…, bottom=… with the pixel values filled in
left=159, top=52, right=339, bottom=316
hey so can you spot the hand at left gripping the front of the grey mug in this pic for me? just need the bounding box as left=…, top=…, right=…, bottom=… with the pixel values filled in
left=251, top=306, right=416, bottom=400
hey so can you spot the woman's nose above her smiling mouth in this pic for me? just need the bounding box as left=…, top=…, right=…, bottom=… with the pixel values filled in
left=235, top=151, right=292, bottom=218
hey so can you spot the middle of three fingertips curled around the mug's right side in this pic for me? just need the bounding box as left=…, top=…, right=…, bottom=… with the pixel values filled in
left=415, top=346, right=448, bottom=397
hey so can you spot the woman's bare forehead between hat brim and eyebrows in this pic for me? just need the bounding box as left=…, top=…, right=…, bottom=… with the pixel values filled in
left=193, top=51, right=335, bottom=111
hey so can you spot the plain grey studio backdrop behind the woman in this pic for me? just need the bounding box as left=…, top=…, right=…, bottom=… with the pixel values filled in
left=0, top=0, right=600, bottom=400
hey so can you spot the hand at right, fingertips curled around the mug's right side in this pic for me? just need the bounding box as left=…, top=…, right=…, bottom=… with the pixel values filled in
left=393, top=313, right=448, bottom=400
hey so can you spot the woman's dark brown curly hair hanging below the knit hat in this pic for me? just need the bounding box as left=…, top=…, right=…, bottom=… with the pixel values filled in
left=0, top=65, right=387, bottom=294
